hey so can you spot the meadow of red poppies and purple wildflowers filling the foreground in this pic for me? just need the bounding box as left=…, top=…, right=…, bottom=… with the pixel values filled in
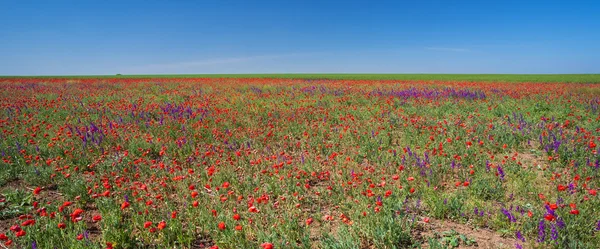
left=0, top=78, right=600, bottom=249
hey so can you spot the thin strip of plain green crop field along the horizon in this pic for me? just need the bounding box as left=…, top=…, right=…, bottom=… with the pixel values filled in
left=0, top=74, right=600, bottom=83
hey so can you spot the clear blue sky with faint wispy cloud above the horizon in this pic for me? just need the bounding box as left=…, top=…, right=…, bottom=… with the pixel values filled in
left=0, top=0, right=600, bottom=75
